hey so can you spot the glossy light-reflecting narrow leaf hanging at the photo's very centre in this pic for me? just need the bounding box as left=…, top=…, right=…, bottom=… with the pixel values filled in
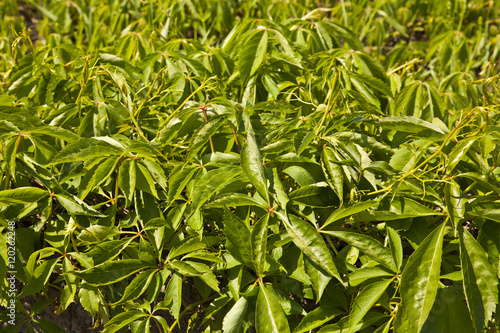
left=241, top=129, right=269, bottom=203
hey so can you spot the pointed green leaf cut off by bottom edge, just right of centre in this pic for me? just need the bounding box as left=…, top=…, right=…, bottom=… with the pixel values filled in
left=255, top=284, right=290, bottom=333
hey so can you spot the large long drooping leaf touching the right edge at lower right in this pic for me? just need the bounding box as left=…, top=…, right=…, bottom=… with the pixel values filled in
left=459, top=227, right=498, bottom=333
